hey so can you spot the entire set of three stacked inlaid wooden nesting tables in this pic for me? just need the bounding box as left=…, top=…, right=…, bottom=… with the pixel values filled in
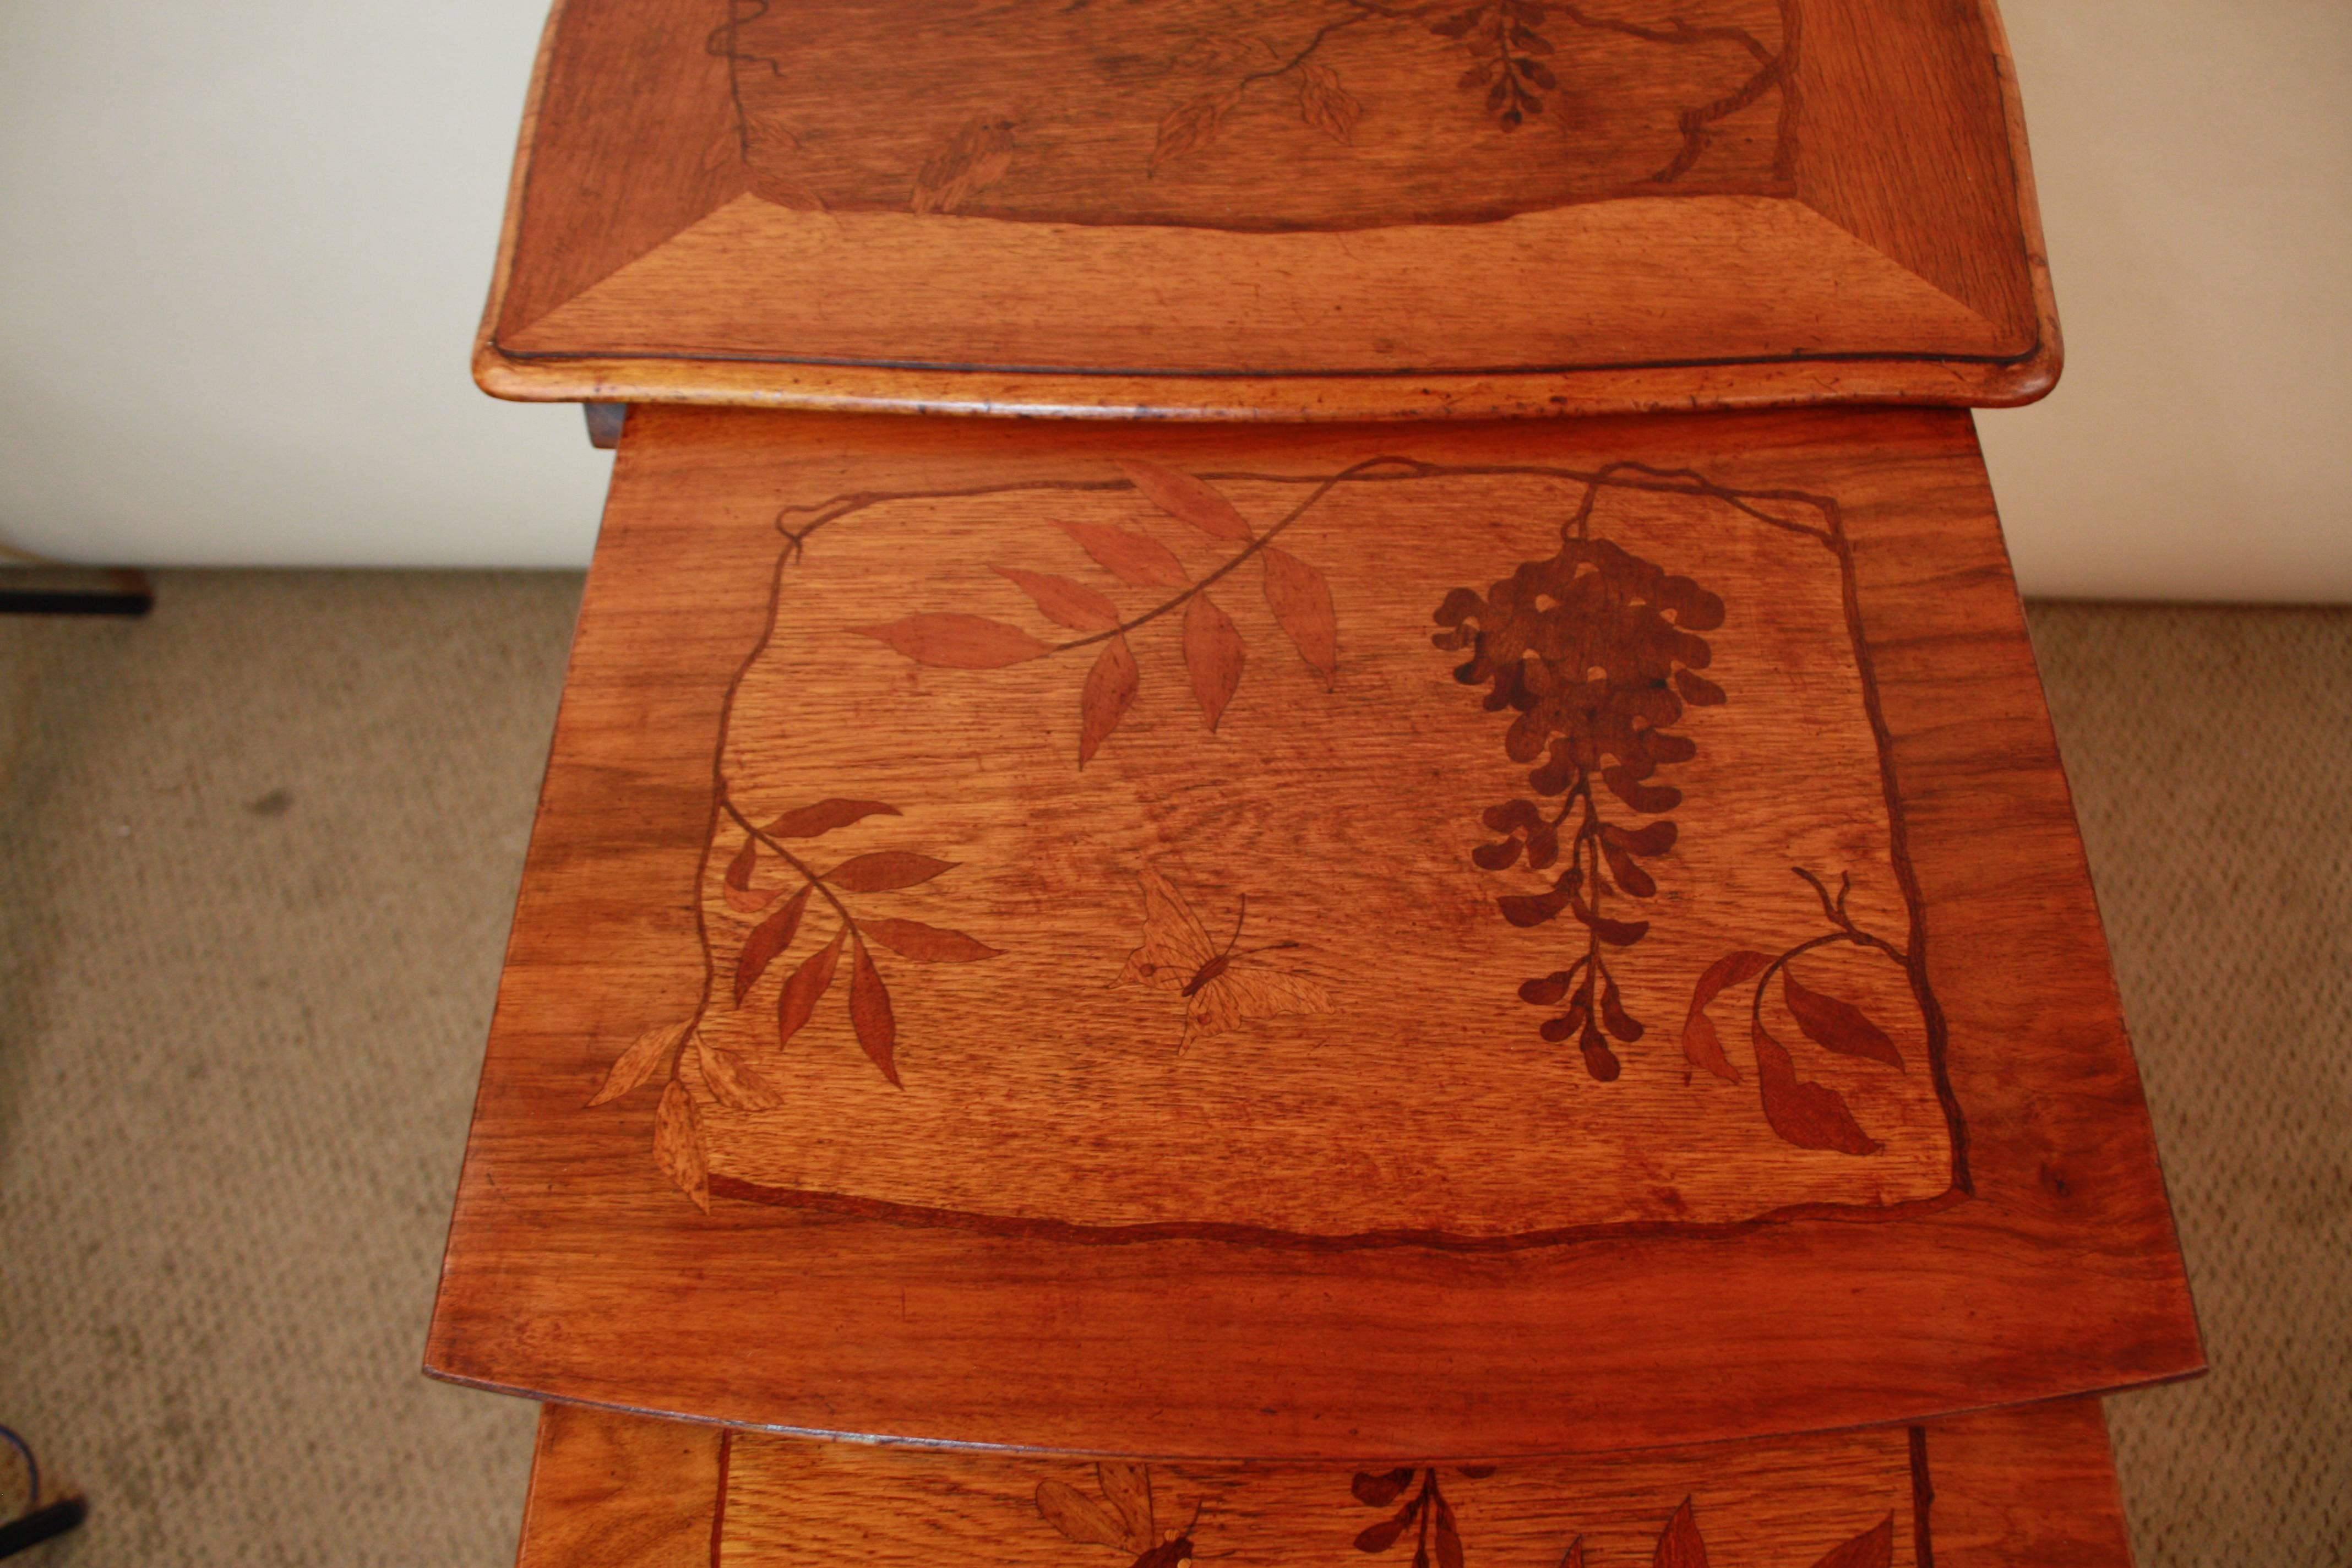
left=428, top=0, right=2202, bottom=1568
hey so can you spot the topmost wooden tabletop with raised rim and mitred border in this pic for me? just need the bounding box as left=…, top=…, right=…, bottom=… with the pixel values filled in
left=475, top=0, right=2058, bottom=418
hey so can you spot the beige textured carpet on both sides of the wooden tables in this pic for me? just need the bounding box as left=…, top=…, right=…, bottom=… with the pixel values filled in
left=0, top=574, right=2352, bottom=1568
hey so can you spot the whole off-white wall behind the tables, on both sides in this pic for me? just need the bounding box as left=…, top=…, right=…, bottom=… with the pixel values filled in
left=0, top=0, right=2352, bottom=600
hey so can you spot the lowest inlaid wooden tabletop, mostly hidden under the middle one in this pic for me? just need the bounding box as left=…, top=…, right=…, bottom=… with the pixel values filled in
left=520, top=1401, right=2131, bottom=1568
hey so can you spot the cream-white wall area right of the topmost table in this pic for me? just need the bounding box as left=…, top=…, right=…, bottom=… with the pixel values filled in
left=1978, top=0, right=2352, bottom=602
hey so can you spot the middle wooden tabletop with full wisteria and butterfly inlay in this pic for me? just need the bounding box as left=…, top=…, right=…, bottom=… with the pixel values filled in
left=428, top=407, right=2199, bottom=1460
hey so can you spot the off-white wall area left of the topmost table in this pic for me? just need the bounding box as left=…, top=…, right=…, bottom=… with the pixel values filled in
left=0, top=0, right=612, bottom=567
